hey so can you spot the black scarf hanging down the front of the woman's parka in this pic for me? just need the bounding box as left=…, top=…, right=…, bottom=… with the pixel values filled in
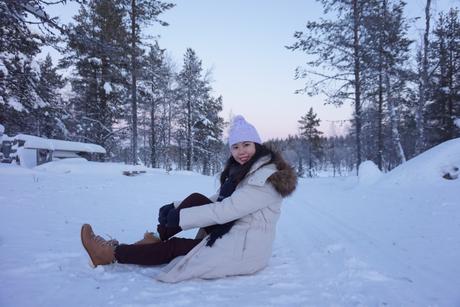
left=206, top=165, right=241, bottom=247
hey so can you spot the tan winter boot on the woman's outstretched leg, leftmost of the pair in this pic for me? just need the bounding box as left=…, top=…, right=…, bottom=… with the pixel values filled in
left=81, top=224, right=115, bottom=267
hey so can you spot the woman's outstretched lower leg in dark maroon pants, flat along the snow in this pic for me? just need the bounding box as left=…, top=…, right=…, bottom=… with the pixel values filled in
left=115, top=238, right=201, bottom=265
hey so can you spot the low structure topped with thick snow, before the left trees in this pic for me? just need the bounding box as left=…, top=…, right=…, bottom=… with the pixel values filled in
left=11, top=134, right=106, bottom=167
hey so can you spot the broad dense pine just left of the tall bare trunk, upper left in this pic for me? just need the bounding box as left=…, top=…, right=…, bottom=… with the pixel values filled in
left=61, top=0, right=127, bottom=152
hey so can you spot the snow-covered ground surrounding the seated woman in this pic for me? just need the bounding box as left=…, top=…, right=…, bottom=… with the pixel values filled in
left=0, top=139, right=460, bottom=306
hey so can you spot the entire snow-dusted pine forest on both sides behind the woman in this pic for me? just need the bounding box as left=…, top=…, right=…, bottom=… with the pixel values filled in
left=0, top=0, right=460, bottom=176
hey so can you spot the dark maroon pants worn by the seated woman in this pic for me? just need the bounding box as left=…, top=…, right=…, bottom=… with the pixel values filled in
left=115, top=193, right=212, bottom=265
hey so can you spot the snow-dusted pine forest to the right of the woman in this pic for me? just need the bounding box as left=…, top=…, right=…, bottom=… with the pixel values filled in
left=287, top=0, right=460, bottom=177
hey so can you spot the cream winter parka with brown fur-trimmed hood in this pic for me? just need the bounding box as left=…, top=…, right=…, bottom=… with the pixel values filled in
left=156, top=154, right=297, bottom=282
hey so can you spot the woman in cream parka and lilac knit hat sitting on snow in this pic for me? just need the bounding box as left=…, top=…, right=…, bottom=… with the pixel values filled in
left=81, top=116, right=297, bottom=282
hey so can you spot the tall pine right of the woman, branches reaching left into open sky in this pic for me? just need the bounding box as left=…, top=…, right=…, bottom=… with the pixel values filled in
left=288, top=0, right=372, bottom=173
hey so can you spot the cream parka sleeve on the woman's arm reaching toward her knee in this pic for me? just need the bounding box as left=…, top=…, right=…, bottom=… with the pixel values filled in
left=179, top=182, right=281, bottom=229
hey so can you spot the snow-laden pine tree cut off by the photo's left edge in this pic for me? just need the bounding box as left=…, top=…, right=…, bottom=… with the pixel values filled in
left=0, top=0, right=65, bottom=133
